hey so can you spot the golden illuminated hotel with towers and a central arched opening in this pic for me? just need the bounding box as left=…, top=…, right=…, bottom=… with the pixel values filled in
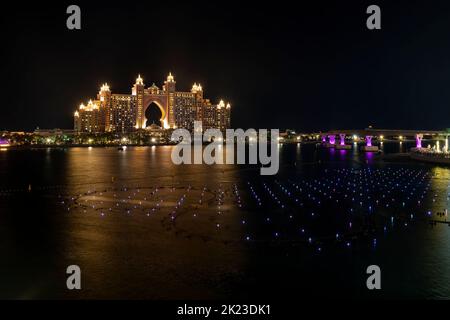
left=74, top=74, right=231, bottom=133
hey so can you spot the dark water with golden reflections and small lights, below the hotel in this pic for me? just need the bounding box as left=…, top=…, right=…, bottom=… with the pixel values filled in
left=0, top=143, right=450, bottom=299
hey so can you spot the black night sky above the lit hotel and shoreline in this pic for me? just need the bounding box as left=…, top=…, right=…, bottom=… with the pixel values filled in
left=0, top=1, right=450, bottom=131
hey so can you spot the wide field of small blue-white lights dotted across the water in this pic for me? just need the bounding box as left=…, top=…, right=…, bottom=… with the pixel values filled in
left=59, top=167, right=449, bottom=252
